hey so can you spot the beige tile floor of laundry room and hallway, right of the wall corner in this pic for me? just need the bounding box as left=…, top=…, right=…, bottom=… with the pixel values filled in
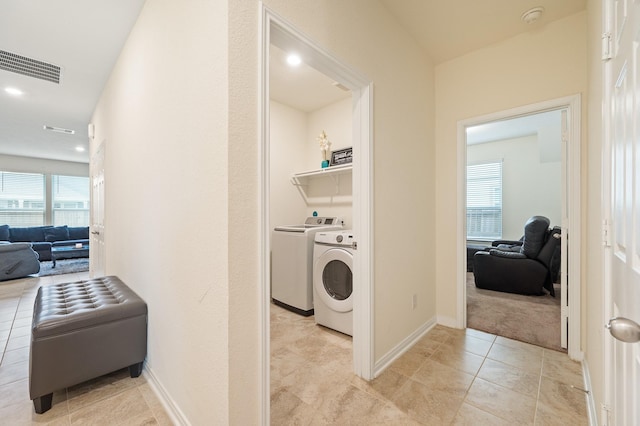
left=271, top=305, right=588, bottom=426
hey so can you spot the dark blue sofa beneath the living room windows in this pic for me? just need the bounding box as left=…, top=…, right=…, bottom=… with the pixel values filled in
left=0, top=225, right=89, bottom=261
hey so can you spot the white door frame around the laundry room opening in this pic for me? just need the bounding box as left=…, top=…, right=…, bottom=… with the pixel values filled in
left=260, top=6, right=373, bottom=422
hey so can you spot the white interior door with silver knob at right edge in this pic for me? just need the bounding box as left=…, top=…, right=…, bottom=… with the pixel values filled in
left=602, top=0, right=640, bottom=426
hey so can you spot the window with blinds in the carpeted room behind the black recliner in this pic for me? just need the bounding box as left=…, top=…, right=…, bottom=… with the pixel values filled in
left=467, top=161, right=502, bottom=240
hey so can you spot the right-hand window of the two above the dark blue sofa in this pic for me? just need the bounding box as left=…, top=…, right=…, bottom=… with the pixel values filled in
left=51, top=175, right=89, bottom=226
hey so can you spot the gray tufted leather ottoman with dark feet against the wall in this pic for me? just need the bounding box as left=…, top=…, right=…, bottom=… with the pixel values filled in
left=29, top=276, right=147, bottom=414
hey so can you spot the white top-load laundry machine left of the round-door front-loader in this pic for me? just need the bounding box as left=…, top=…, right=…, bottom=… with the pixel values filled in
left=271, top=216, right=342, bottom=316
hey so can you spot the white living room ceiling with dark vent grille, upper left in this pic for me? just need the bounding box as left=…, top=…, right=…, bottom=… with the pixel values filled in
left=0, top=0, right=144, bottom=163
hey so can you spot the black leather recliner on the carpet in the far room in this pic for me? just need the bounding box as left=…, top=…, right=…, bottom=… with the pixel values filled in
left=473, top=216, right=561, bottom=296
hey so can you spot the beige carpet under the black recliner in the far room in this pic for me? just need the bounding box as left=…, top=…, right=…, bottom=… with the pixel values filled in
left=467, top=272, right=566, bottom=352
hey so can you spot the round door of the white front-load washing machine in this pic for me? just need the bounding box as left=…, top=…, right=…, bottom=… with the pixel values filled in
left=313, top=248, right=353, bottom=312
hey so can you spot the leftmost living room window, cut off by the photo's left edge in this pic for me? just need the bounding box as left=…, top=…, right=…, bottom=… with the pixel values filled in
left=0, top=171, right=46, bottom=226
